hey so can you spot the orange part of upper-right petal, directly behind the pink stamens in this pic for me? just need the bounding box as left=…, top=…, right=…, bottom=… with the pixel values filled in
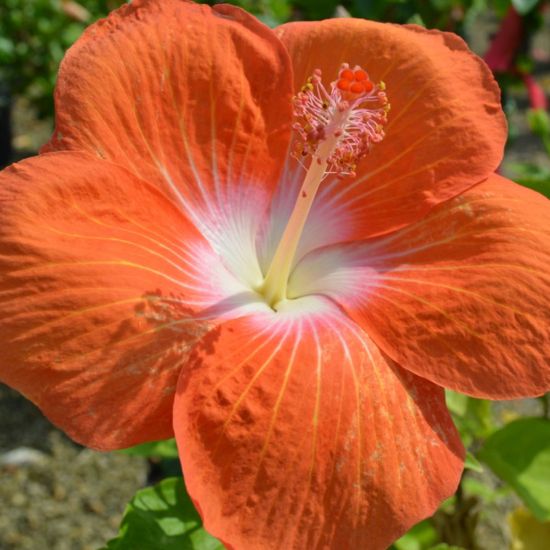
left=276, top=19, right=506, bottom=239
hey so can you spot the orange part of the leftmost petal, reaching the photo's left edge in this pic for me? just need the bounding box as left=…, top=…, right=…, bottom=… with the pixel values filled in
left=0, top=153, right=219, bottom=449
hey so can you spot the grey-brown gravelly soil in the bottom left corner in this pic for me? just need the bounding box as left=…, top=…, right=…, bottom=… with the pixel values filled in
left=0, top=385, right=152, bottom=550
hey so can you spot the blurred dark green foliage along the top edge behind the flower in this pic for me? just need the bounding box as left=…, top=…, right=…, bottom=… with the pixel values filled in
left=0, top=0, right=538, bottom=118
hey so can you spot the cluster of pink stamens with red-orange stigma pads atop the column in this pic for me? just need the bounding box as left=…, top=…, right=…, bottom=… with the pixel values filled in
left=293, top=63, right=390, bottom=178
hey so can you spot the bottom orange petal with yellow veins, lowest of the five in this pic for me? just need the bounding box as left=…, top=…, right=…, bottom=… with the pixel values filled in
left=174, top=307, right=463, bottom=550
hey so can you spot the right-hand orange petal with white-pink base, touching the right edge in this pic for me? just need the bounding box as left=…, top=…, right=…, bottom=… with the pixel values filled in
left=294, top=176, right=550, bottom=399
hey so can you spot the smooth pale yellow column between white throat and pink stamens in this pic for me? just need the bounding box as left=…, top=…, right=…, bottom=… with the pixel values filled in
left=258, top=138, right=336, bottom=309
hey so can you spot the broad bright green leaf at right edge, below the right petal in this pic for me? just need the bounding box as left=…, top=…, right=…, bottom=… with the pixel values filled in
left=477, top=418, right=550, bottom=521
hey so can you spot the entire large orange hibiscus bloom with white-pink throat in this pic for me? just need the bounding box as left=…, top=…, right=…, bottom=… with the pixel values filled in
left=0, top=0, right=550, bottom=549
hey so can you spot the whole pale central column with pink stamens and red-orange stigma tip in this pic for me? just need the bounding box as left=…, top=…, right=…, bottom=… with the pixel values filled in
left=256, top=63, right=390, bottom=310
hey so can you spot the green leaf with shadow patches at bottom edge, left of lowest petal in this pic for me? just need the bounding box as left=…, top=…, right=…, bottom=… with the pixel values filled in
left=103, top=477, right=224, bottom=550
